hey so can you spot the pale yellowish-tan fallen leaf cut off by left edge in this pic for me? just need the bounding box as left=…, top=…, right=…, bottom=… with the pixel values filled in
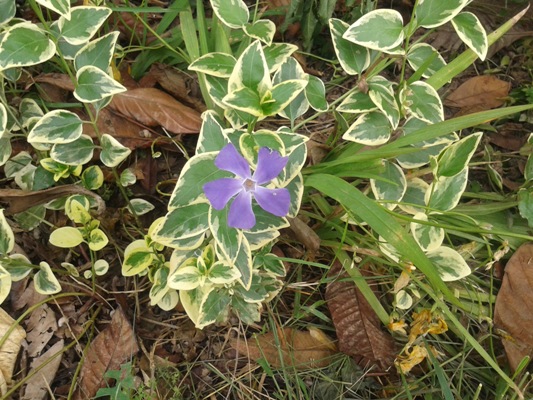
left=0, top=308, right=26, bottom=396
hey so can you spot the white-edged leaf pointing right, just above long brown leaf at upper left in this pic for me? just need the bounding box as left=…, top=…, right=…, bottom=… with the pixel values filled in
left=74, top=65, right=127, bottom=103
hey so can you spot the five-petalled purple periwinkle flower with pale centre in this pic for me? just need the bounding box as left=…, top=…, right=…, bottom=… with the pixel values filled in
left=203, top=143, right=291, bottom=229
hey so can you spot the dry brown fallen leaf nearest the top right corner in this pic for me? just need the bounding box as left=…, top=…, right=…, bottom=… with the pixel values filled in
left=444, top=75, right=511, bottom=111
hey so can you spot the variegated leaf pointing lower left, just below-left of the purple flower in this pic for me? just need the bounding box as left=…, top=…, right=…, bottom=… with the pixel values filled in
left=152, top=203, right=211, bottom=245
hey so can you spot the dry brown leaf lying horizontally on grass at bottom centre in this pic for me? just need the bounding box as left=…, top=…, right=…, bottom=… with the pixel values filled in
left=230, top=328, right=337, bottom=369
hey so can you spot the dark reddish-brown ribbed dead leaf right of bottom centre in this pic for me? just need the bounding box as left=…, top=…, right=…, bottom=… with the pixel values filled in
left=326, top=262, right=396, bottom=370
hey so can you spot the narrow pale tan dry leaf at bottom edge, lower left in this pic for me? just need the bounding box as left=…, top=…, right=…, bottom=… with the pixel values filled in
left=21, top=340, right=65, bottom=400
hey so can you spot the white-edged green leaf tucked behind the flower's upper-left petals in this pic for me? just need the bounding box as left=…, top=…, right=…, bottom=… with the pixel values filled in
left=168, top=151, right=224, bottom=210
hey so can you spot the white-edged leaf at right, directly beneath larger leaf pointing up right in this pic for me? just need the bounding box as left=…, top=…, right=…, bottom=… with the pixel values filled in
left=425, top=168, right=468, bottom=211
